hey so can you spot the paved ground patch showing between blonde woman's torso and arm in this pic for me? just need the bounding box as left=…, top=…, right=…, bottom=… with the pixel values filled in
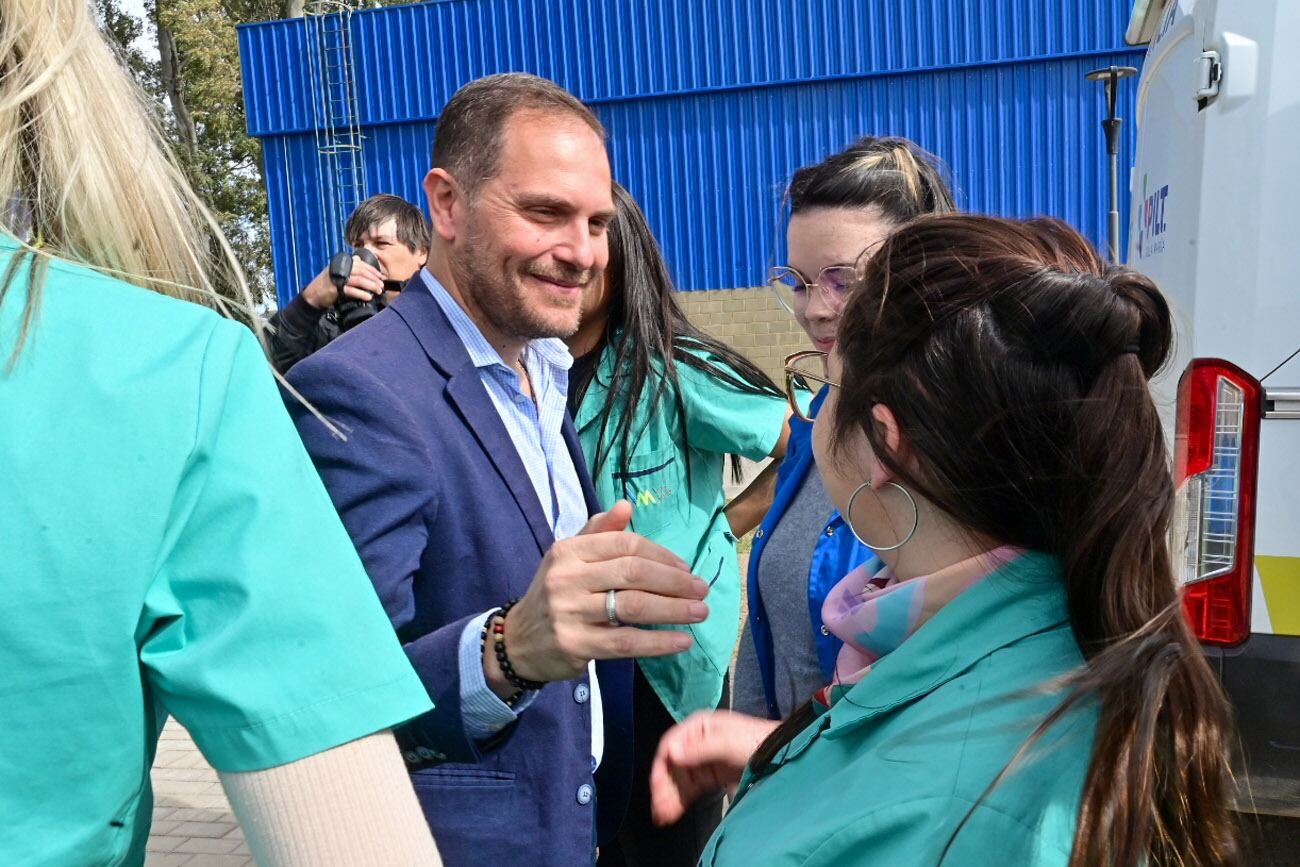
left=144, top=720, right=254, bottom=867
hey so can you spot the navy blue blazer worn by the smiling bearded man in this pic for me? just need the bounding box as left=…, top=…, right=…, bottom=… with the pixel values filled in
left=286, top=286, right=632, bottom=867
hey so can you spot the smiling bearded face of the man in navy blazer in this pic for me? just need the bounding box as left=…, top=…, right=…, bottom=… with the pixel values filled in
left=449, top=110, right=614, bottom=341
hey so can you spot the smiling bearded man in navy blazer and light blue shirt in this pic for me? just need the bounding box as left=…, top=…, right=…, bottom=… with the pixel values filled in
left=289, top=74, right=707, bottom=867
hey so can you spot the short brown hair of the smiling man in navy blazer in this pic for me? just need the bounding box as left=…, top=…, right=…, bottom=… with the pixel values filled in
left=433, top=73, right=605, bottom=196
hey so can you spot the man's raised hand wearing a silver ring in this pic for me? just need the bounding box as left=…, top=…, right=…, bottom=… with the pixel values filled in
left=484, top=500, right=709, bottom=697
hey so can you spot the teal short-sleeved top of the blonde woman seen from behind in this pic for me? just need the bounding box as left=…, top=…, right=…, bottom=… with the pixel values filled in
left=0, top=235, right=432, bottom=866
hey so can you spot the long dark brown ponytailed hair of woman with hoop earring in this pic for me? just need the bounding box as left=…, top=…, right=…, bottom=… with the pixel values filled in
left=754, top=216, right=1239, bottom=867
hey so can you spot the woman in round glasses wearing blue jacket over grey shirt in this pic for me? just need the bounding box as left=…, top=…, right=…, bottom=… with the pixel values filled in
left=732, top=136, right=953, bottom=719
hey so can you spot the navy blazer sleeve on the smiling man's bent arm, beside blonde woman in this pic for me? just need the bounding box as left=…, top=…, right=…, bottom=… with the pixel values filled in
left=285, top=354, right=483, bottom=764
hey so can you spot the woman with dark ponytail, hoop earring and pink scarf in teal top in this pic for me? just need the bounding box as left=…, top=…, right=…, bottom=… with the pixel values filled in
left=653, top=216, right=1240, bottom=867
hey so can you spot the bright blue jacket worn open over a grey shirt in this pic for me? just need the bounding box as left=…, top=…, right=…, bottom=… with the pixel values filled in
left=748, top=386, right=876, bottom=720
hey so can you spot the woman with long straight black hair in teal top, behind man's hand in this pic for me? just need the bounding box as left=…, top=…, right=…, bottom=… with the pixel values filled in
left=568, top=183, right=789, bottom=867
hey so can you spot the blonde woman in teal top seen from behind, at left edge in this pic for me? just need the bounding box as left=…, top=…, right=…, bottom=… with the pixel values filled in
left=0, top=0, right=438, bottom=866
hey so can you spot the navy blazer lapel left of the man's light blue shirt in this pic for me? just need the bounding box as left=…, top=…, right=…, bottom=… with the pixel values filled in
left=379, top=288, right=553, bottom=554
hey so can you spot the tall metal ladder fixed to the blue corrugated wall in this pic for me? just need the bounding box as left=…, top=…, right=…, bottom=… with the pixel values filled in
left=303, top=0, right=365, bottom=255
